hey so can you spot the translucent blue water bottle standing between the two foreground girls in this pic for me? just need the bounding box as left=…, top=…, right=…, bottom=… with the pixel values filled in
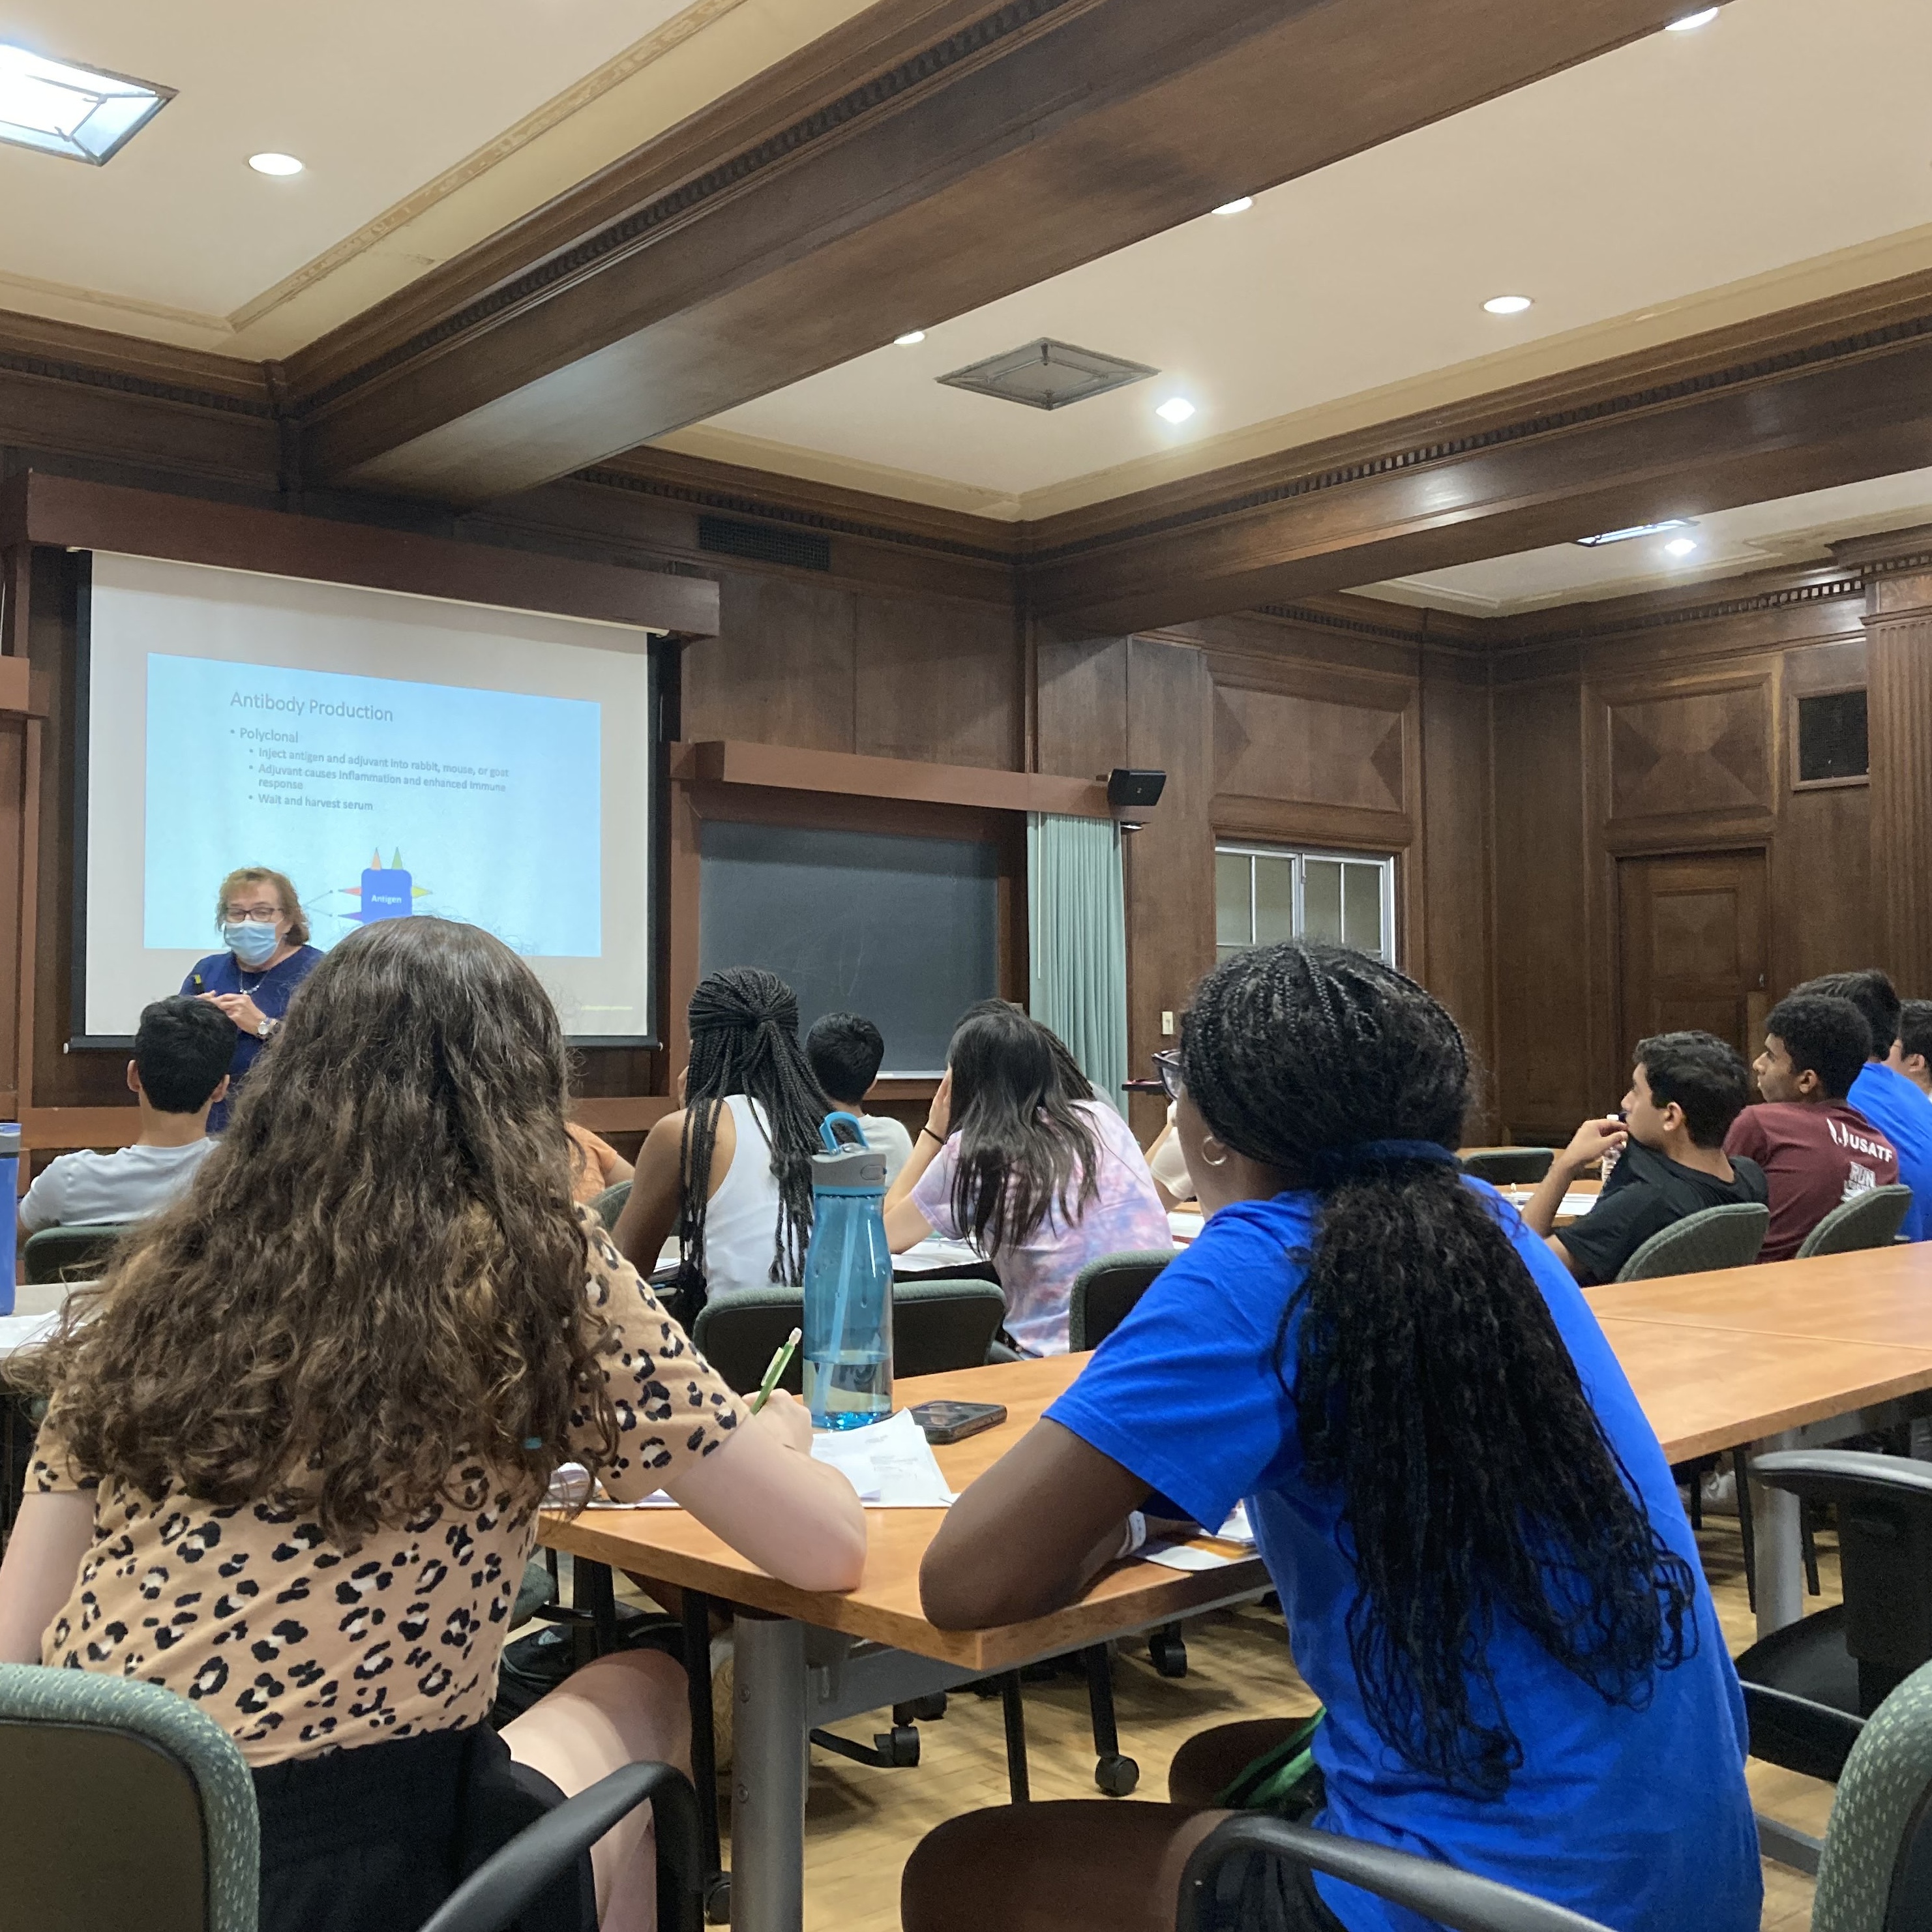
left=806, top=1113, right=893, bottom=1430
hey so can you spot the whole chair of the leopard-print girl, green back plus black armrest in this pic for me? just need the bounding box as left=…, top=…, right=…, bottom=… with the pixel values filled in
left=0, top=1663, right=702, bottom=1932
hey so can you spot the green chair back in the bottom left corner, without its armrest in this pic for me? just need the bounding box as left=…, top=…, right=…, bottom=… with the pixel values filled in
left=0, top=1663, right=261, bottom=1932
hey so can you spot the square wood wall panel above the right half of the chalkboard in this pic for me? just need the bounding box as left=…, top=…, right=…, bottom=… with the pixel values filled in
left=854, top=595, right=1026, bottom=771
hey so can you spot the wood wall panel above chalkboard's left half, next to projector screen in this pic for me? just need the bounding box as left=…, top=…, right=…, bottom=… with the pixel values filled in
left=684, top=570, right=860, bottom=752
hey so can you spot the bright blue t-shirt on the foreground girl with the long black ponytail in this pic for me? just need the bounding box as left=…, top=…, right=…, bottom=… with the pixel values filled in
left=1047, top=1180, right=1762, bottom=1932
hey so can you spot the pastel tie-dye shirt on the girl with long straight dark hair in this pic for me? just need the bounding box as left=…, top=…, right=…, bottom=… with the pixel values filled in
left=912, top=1099, right=1175, bottom=1354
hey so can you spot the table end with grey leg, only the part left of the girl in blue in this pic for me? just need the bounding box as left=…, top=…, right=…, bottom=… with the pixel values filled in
left=543, top=1356, right=1270, bottom=1932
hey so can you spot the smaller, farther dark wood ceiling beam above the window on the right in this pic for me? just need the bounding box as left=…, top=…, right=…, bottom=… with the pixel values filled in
left=1026, top=276, right=1932, bottom=634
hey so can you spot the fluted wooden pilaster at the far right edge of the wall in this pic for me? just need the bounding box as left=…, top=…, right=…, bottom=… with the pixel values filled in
left=1866, top=570, right=1932, bottom=997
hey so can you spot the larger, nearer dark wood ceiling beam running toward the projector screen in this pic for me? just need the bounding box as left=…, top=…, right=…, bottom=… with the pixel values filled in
left=288, top=0, right=1708, bottom=504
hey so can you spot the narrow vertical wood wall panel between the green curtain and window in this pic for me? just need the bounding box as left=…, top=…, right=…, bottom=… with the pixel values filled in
left=1124, top=638, right=1215, bottom=1146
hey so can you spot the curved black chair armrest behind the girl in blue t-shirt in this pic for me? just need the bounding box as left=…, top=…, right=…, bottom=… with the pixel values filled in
left=1175, top=1812, right=1603, bottom=1932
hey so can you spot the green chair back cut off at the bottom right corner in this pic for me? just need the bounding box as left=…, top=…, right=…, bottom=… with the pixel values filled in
left=1810, top=1663, right=1932, bottom=1932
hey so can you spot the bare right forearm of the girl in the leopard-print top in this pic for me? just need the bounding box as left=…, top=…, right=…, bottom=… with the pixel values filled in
left=664, top=1389, right=865, bottom=1590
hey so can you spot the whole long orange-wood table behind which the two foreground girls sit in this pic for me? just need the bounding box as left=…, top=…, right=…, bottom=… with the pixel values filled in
left=543, top=1244, right=1932, bottom=1932
